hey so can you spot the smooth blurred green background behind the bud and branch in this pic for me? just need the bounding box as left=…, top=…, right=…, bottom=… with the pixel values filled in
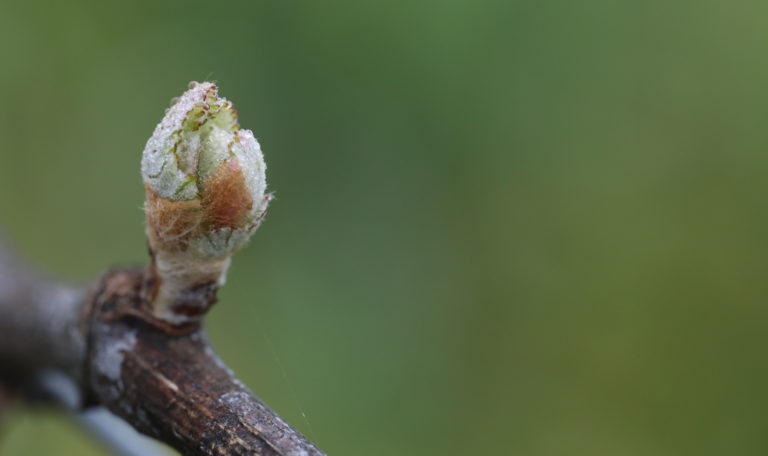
left=0, top=0, right=768, bottom=456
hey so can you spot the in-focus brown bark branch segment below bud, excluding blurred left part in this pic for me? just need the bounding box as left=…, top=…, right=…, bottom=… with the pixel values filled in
left=86, top=270, right=322, bottom=456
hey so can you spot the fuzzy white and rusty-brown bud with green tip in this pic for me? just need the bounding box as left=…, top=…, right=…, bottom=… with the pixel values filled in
left=141, top=82, right=270, bottom=323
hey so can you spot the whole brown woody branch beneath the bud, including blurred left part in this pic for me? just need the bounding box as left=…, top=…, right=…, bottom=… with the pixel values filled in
left=0, top=240, right=323, bottom=456
